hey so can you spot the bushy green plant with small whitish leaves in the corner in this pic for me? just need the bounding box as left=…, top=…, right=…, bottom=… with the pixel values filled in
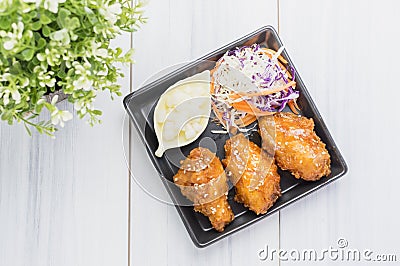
left=0, top=0, right=144, bottom=135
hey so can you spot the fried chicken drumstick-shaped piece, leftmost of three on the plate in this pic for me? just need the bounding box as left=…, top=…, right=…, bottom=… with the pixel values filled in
left=174, top=147, right=234, bottom=232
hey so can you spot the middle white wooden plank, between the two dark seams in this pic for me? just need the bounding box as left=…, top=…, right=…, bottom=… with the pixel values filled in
left=131, top=0, right=279, bottom=265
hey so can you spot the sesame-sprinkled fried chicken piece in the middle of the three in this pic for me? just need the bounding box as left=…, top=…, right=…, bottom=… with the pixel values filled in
left=222, top=134, right=281, bottom=215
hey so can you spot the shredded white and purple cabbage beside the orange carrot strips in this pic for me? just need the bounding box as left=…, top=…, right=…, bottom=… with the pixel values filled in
left=213, top=44, right=299, bottom=130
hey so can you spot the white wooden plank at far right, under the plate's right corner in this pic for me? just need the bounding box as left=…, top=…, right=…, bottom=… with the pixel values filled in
left=280, top=0, right=400, bottom=265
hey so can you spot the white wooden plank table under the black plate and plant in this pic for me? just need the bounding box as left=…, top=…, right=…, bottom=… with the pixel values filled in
left=0, top=0, right=400, bottom=266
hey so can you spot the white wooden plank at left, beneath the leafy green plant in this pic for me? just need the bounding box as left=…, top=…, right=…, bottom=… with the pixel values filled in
left=0, top=31, right=130, bottom=266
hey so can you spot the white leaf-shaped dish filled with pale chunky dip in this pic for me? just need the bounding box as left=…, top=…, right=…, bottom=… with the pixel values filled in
left=154, top=70, right=211, bottom=157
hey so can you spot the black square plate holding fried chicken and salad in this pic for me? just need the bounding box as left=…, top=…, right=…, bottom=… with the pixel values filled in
left=124, top=26, right=347, bottom=247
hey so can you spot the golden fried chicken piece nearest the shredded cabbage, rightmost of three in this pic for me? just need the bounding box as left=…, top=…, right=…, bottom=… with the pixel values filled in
left=259, top=113, right=331, bottom=181
